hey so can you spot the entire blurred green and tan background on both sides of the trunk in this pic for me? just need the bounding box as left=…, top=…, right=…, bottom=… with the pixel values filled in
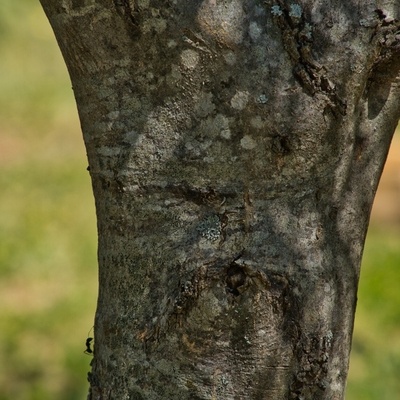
left=0, top=0, right=400, bottom=400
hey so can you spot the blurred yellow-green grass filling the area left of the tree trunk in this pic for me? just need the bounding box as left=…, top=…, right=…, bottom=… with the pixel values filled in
left=0, top=0, right=97, bottom=400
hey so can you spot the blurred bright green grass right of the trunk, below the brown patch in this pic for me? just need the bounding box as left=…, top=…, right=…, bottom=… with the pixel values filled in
left=346, top=227, right=400, bottom=400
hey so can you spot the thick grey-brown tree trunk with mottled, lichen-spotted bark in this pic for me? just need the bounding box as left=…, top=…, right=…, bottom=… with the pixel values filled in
left=41, top=0, right=400, bottom=400
